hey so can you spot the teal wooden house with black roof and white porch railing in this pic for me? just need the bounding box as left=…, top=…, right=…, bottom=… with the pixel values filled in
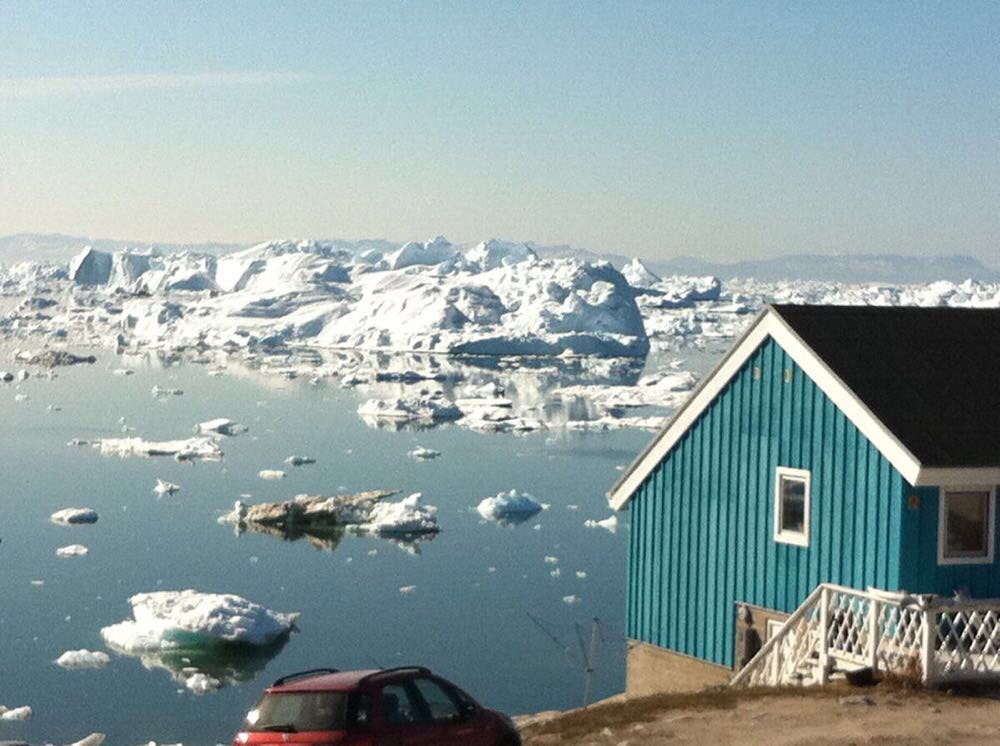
left=609, top=305, right=1000, bottom=693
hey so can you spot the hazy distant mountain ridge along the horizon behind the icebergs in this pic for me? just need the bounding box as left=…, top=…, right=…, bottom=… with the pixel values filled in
left=0, top=233, right=1000, bottom=284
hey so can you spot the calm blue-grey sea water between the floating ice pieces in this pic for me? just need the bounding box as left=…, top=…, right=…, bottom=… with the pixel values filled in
left=0, top=354, right=664, bottom=746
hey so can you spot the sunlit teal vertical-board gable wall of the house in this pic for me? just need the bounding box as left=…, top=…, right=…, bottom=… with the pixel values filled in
left=626, top=339, right=908, bottom=666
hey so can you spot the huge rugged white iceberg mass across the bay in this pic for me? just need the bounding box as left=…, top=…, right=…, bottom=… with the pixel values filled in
left=13, top=237, right=649, bottom=356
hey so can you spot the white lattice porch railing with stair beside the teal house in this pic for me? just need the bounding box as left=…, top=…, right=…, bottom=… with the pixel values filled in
left=731, top=583, right=1000, bottom=687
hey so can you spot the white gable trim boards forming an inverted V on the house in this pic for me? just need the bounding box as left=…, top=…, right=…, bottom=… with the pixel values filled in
left=608, top=307, right=927, bottom=510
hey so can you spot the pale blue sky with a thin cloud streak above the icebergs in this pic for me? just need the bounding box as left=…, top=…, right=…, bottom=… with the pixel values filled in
left=0, top=0, right=1000, bottom=265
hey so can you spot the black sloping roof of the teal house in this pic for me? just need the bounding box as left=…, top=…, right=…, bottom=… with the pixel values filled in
left=773, top=305, right=1000, bottom=467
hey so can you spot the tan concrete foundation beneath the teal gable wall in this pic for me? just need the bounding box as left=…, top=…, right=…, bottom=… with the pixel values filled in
left=625, top=640, right=733, bottom=697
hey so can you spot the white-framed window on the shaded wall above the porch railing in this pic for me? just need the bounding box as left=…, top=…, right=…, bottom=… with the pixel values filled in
left=938, top=488, right=996, bottom=565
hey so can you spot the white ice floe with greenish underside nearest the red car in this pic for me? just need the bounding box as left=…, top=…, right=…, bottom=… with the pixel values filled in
left=101, top=590, right=298, bottom=653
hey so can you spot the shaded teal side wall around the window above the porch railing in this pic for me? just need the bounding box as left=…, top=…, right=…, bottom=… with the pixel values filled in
left=898, top=483, right=1000, bottom=598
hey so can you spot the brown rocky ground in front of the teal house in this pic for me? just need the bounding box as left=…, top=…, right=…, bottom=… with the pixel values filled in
left=518, top=684, right=1000, bottom=746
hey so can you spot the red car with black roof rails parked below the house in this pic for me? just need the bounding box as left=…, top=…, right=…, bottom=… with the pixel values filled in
left=233, top=666, right=521, bottom=746
